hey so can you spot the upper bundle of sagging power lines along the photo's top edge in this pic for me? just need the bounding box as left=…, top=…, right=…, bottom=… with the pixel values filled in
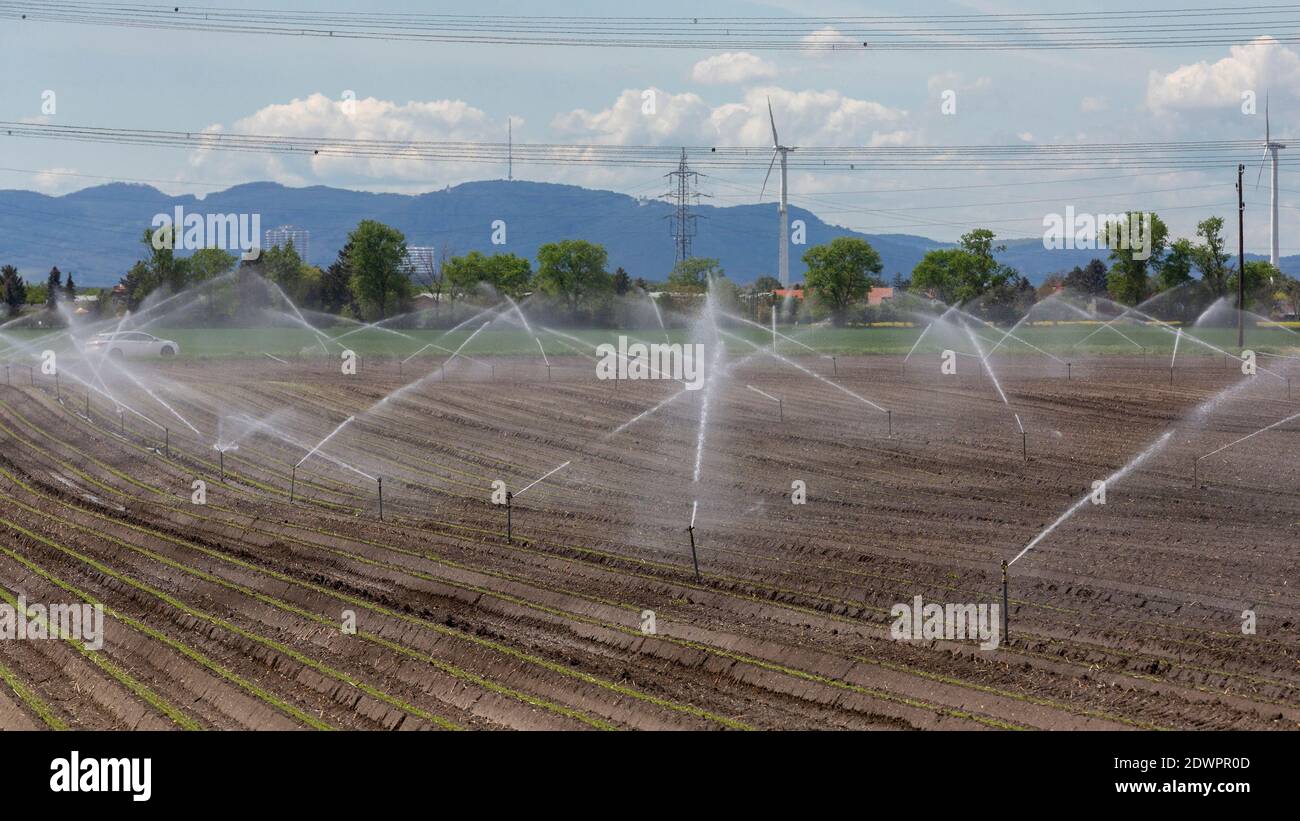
left=0, top=0, right=1300, bottom=53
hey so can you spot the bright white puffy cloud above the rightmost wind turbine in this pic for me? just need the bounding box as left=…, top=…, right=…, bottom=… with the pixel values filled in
left=1147, top=38, right=1300, bottom=113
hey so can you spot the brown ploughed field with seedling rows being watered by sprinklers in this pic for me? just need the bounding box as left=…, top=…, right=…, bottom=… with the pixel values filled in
left=0, top=357, right=1300, bottom=729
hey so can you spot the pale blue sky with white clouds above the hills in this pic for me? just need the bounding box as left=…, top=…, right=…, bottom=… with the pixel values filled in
left=0, top=0, right=1300, bottom=255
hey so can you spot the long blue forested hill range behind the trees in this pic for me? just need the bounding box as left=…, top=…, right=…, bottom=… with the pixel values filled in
left=0, top=181, right=1300, bottom=286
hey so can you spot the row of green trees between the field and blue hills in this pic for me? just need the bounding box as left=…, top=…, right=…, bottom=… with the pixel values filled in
left=0, top=214, right=1300, bottom=325
